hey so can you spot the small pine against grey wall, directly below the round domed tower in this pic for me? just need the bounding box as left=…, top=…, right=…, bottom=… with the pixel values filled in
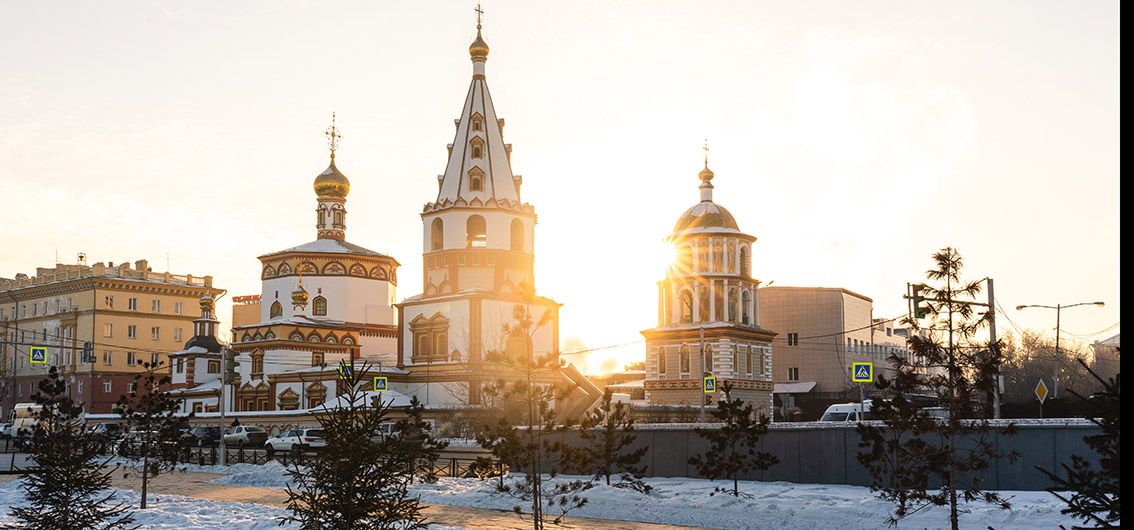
left=689, top=381, right=779, bottom=497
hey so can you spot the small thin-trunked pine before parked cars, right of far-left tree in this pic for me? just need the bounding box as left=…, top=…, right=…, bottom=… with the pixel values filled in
left=115, top=362, right=193, bottom=510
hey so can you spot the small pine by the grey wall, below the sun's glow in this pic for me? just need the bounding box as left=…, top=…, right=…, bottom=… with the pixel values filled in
left=576, top=389, right=652, bottom=494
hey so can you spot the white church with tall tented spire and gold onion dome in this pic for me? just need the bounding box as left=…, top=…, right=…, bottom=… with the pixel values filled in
left=174, top=17, right=601, bottom=414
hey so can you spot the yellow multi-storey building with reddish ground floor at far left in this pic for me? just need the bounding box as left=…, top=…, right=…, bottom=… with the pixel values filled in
left=0, top=255, right=222, bottom=415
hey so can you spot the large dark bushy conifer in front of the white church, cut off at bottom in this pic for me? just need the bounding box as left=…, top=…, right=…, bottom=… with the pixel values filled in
left=280, top=361, right=425, bottom=530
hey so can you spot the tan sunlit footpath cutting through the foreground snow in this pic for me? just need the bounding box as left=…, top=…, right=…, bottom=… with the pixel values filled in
left=104, top=472, right=696, bottom=530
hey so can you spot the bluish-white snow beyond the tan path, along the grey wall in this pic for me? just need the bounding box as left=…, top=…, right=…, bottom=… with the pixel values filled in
left=214, top=463, right=1074, bottom=530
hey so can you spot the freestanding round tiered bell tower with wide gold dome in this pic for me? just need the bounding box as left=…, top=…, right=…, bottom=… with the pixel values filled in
left=642, top=160, right=778, bottom=417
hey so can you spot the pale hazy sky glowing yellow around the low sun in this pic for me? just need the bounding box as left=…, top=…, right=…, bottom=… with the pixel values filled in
left=0, top=0, right=1120, bottom=372
